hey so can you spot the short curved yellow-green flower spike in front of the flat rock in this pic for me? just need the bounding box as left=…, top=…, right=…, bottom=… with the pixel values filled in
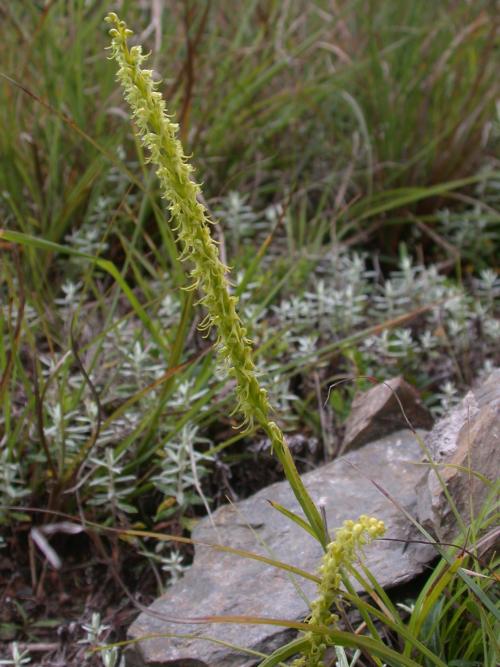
left=292, top=515, right=385, bottom=667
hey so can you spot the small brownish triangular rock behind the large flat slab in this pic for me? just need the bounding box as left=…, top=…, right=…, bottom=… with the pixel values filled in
left=341, top=377, right=433, bottom=452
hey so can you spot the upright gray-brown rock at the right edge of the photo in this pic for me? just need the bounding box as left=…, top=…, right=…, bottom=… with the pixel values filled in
left=417, top=369, right=500, bottom=541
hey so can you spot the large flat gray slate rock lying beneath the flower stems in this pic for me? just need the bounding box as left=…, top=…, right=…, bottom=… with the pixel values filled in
left=126, top=430, right=435, bottom=667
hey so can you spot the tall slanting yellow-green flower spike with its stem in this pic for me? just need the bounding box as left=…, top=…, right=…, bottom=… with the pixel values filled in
left=106, top=12, right=327, bottom=548
